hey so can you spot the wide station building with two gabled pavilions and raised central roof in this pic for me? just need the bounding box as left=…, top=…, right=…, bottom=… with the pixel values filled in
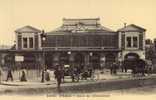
left=0, top=18, right=146, bottom=68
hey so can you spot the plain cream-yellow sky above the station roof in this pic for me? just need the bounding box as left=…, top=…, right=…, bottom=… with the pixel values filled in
left=0, top=0, right=156, bottom=45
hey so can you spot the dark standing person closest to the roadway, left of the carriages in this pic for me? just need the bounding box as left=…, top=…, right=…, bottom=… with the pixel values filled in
left=54, top=65, right=62, bottom=92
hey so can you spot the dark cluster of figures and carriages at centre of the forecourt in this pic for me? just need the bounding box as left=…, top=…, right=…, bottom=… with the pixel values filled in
left=54, top=65, right=99, bottom=91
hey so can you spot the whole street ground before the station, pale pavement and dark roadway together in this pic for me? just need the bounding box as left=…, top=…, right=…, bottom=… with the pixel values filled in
left=0, top=71, right=156, bottom=96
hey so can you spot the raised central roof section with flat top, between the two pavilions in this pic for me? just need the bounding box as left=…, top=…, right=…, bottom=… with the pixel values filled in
left=48, top=18, right=114, bottom=34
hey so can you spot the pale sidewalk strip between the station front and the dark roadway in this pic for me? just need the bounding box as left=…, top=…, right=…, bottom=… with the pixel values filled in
left=0, top=71, right=156, bottom=86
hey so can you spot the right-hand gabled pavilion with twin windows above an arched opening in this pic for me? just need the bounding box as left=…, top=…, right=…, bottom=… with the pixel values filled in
left=118, top=24, right=146, bottom=60
